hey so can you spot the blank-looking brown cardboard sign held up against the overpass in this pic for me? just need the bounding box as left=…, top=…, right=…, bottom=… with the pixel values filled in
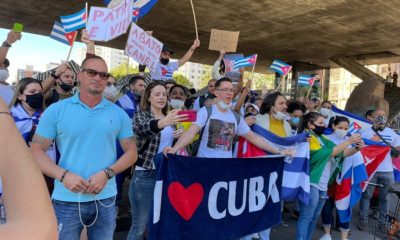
left=208, top=29, right=240, bottom=52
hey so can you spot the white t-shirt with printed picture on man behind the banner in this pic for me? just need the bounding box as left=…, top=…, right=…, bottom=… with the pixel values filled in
left=194, top=105, right=250, bottom=158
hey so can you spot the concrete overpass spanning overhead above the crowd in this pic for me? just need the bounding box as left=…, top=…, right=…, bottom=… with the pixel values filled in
left=0, top=0, right=400, bottom=116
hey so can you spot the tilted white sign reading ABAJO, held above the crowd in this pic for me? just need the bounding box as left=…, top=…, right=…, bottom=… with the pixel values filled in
left=125, top=23, right=163, bottom=71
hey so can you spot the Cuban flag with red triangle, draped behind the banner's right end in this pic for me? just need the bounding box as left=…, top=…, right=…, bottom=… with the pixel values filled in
left=238, top=124, right=310, bottom=204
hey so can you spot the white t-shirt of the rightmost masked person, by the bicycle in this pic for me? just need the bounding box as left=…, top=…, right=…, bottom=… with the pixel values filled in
left=361, top=127, right=400, bottom=172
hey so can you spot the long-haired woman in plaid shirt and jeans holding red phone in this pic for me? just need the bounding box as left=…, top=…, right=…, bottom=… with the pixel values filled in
left=128, top=81, right=187, bottom=240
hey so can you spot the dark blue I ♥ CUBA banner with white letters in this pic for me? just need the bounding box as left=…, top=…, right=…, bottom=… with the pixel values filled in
left=149, top=154, right=284, bottom=240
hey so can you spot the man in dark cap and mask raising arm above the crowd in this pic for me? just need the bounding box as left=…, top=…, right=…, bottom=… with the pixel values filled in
left=150, top=39, right=200, bottom=81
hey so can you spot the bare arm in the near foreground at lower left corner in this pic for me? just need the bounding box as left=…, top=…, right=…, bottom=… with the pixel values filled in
left=0, top=99, right=57, bottom=240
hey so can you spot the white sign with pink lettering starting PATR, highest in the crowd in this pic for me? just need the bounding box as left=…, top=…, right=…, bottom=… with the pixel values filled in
left=86, top=0, right=132, bottom=42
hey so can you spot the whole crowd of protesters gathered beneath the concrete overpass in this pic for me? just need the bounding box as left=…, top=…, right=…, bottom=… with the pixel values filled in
left=0, top=26, right=400, bottom=240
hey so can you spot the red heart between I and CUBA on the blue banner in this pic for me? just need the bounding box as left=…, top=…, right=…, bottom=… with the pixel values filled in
left=168, top=182, right=204, bottom=221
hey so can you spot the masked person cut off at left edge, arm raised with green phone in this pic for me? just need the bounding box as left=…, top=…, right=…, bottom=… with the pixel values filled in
left=0, top=31, right=21, bottom=105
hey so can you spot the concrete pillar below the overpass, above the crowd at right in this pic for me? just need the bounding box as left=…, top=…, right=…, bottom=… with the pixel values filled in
left=331, top=56, right=389, bottom=116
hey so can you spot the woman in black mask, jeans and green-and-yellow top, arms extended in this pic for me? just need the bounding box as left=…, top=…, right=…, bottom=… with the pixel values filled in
left=296, top=112, right=362, bottom=240
